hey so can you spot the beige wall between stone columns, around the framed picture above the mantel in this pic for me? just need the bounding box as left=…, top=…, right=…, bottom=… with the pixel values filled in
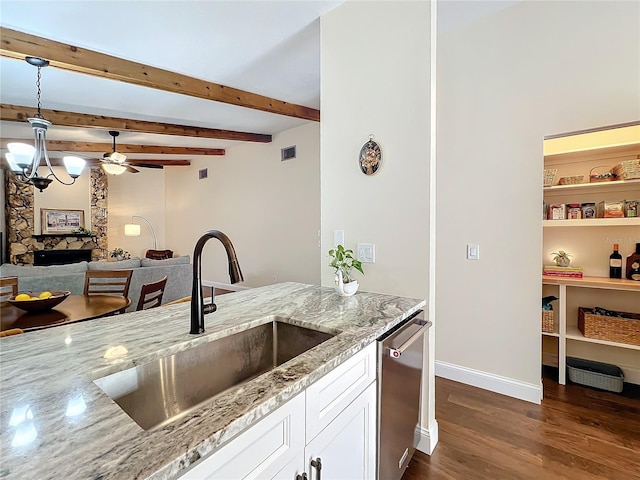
left=33, top=167, right=91, bottom=235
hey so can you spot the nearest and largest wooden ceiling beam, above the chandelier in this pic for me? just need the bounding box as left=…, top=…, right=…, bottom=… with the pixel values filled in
left=0, top=27, right=320, bottom=122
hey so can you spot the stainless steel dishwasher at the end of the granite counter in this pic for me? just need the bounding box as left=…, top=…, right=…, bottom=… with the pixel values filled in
left=378, top=310, right=431, bottom=480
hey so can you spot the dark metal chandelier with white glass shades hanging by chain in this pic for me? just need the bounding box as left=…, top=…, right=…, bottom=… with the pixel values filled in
left=5, top=57, right=86, bottom=192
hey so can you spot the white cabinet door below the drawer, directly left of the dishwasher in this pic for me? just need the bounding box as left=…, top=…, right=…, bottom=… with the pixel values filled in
left=305, top=382, right=377, bottom=480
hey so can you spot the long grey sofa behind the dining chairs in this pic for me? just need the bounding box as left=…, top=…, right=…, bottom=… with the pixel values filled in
left=0, top=255, right=193, bottom=312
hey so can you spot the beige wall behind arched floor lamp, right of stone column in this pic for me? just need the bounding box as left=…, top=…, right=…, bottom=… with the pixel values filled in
left=107, top=167, right=165, bottom=258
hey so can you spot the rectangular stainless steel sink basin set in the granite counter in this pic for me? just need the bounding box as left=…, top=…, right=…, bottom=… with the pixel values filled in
left=94, top=318, right=334, bottom=430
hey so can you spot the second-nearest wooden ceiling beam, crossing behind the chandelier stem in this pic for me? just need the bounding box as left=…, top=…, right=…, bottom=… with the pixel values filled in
left=0, top=103, right=271, bottom=143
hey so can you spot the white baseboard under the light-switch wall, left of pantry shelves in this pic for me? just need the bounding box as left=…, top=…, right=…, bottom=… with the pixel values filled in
left=436, top=361, right=542, bottom=404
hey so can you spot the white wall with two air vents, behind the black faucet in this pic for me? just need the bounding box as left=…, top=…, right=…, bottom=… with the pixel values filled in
left=166, top=123, right=320, bottom=287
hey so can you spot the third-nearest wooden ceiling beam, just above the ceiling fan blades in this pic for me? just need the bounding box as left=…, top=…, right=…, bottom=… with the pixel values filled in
left=0, top=138, right=225, bottom=155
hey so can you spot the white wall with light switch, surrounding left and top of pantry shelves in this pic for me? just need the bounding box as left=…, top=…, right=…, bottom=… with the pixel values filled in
left=436, top=1, right=640, bottom=401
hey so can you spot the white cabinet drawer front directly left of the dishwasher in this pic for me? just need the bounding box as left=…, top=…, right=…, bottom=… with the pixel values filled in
left=306, top=342, right=376, bottom=443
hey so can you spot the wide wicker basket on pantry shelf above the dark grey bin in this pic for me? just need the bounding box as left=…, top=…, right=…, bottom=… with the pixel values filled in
left=578, top=307, right=640, bottom=345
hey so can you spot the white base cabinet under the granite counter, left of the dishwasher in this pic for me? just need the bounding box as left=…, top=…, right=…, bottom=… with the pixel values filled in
left=182, top=343, right=377, bottom=480
